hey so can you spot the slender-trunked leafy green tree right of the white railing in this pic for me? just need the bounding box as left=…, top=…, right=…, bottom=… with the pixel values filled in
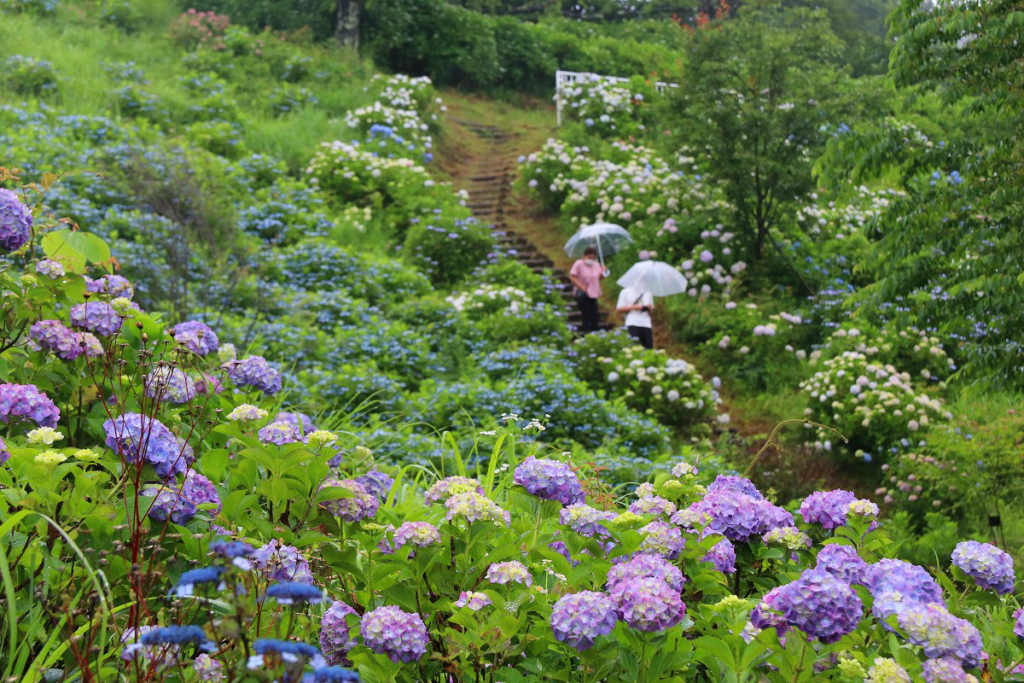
left=675, top=0, right=842, bottom=260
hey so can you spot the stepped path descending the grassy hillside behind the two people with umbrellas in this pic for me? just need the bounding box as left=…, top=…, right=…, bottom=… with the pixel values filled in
left=458, top=120, right=614, bottom=334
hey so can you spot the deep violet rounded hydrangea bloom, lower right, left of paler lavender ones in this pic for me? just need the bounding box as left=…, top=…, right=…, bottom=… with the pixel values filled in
left=751, top=569, right=864, bottom=643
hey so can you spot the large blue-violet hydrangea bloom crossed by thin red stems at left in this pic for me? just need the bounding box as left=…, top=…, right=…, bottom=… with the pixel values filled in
left=103, top=413, right=195, bottom=479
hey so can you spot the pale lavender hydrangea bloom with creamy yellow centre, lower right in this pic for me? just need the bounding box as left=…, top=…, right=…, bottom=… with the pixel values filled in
left=896, top=603, right=982, bottom=669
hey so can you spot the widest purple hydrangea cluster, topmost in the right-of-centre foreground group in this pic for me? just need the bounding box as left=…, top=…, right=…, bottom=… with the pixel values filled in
left=672, top=485, right=793, bottom=543
